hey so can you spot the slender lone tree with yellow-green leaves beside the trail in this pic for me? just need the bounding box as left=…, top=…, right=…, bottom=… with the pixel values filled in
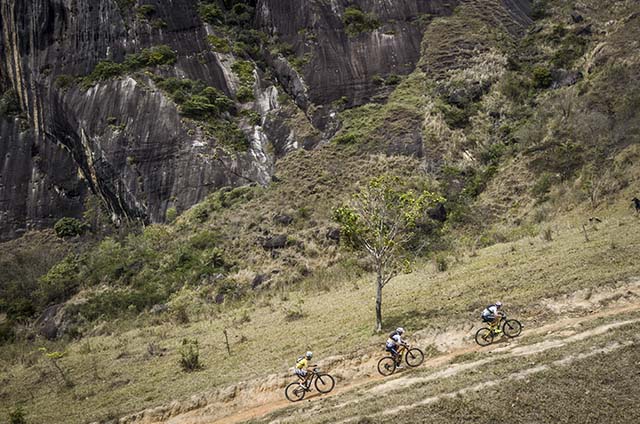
left=334, top=175, right=444, bottom=331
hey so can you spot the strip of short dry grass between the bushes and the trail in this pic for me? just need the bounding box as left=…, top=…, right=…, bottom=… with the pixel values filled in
left=0, top=200, right=640, bottom=423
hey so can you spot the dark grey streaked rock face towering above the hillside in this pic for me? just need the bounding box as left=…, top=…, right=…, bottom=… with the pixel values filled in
left=0, top=0, right=529, bottom=240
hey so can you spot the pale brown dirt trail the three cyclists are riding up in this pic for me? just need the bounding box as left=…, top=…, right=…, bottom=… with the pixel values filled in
left=135, top=279, right=640, bottom=424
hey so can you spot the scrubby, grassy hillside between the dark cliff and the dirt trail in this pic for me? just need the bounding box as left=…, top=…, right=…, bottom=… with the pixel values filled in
left=0, top=1, right=640, bottom=424
